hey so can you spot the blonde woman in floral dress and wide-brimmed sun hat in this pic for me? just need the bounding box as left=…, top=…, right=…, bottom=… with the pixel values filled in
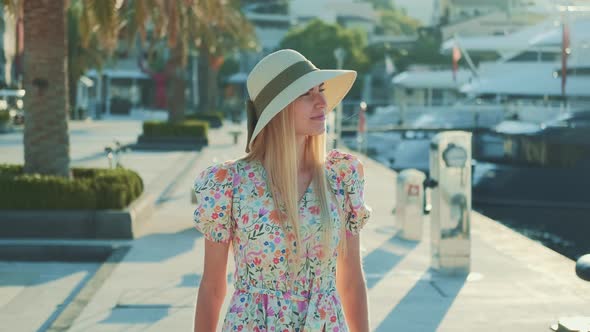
left=194, top=50, right=370, bottom=332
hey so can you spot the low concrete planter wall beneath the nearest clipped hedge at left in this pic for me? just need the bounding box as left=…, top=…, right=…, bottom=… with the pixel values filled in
left=0, top=193, right=156, bottom=239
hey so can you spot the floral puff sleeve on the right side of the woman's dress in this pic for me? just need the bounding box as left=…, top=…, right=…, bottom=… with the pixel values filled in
left=328, top=150, right=372, bottom=235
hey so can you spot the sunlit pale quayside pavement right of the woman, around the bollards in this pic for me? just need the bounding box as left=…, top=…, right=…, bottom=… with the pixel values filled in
left=346, top=149, right=590, bottom=331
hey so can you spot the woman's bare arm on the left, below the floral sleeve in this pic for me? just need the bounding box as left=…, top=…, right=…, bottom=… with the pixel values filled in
left=194, top=240, right=230, bottom=332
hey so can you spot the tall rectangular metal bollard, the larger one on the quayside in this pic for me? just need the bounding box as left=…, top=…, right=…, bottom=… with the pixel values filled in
left=429, top=131, right=471, bottom=273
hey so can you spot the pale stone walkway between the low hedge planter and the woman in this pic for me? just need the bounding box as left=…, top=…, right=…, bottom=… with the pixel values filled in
left=70, top=122, right=243, bottom=331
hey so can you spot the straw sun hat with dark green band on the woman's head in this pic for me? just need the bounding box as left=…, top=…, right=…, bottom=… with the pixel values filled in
left=246, top=49, right=356, bottom=152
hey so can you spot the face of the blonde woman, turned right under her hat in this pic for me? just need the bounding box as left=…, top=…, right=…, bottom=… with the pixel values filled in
left=293, top=83, right=327, bottom=136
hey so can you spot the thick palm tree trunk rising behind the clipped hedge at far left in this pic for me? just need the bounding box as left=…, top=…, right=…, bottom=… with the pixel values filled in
left=24, top=0, right=70, bottom=177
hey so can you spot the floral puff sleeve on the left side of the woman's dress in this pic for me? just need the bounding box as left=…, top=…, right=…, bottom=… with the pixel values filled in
left=193, top=162, right=234, bottom=242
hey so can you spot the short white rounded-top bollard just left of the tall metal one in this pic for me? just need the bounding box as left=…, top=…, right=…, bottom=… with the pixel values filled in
left=395, top=169, right=426, bottom=241
